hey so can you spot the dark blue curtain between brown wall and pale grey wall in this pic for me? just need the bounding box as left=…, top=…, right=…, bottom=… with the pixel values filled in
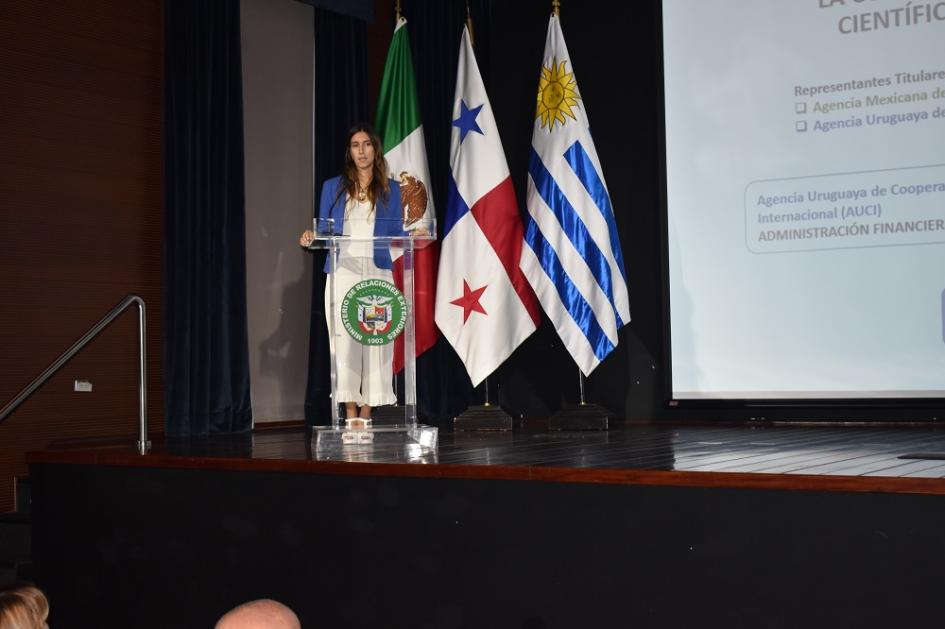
left=164, top=0, right=252, bottom=436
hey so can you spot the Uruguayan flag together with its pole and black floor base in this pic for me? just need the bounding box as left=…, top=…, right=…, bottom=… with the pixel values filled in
left=519, top=0, right=630, bottom=430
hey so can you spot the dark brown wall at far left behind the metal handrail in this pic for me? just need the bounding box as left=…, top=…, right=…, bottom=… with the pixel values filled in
left=0, top=0, right=164, bottom=512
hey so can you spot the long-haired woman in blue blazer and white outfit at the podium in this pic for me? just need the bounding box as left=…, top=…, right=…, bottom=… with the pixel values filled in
left=299, top=124, right=407, bottom=419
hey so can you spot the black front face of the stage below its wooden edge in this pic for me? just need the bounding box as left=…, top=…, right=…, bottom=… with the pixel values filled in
left=33, top=464, right=945, bottom=629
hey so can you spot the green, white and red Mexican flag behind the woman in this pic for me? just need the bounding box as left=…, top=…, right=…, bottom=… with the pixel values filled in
left=375, top=18, right=439, bottom=372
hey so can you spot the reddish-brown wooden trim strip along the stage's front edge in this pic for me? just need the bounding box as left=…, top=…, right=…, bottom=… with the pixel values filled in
left=27, top=448, right=945, bottom=495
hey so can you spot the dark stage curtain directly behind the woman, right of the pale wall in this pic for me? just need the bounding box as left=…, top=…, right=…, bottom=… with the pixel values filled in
left=305, top=8, right=368, bottom=426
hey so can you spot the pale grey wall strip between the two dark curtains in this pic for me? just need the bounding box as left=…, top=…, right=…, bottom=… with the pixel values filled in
left=240, top=0, right=314, bottom=422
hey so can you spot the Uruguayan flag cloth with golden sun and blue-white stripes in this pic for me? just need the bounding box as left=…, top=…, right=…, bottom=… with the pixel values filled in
left=520, top=15, right=630, bottom=375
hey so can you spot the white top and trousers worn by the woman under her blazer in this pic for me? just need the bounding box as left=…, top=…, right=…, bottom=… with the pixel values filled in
left=325, top=198, right=397, bottom=406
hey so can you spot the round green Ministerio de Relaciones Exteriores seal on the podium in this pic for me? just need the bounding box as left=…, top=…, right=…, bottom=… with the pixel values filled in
left=341, top=279, right=407, bottom=345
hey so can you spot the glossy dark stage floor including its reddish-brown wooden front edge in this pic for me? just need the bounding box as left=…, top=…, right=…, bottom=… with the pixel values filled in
left=30, top=424, right=945, bottom=494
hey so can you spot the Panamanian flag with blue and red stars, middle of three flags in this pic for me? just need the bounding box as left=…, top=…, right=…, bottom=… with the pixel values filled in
left=436, top=28, right=541, bottom=386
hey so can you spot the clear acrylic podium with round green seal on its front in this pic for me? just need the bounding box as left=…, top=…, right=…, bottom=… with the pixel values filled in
left=310, top=216, right=437, bottom=460
